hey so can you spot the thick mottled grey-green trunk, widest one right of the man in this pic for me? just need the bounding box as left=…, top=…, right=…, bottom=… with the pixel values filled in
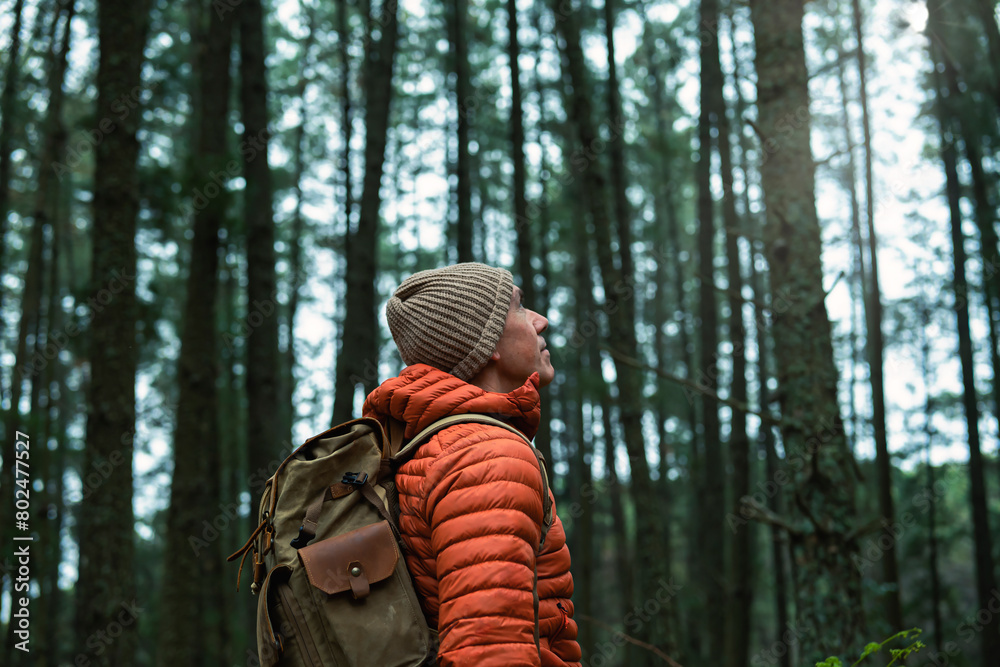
left=750, top=0, right=864, bottom=664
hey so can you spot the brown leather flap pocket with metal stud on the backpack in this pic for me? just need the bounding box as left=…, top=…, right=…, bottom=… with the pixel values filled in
left=299, top=521, right=399, bottom=599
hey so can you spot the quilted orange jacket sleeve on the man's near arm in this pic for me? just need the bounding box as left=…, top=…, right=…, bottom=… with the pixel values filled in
left=427, top=425, right=542, bottom=667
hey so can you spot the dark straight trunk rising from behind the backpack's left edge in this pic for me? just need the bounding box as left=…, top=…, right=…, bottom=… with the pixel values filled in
left=243, top=0, right=284, bottom=494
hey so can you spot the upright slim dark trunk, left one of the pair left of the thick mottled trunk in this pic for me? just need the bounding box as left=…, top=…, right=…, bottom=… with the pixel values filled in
left=695, top=0, right=727, bottom=665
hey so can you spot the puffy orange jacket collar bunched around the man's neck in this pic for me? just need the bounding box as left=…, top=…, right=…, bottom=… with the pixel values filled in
left=362, top=364, right=541, bottom=439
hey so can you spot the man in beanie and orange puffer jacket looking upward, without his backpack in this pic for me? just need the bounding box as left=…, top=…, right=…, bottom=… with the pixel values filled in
left=364, top=263, right=580, bottom=667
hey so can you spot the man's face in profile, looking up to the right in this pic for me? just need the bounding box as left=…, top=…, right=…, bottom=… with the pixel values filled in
left=493, top=287, right=556, bottom=387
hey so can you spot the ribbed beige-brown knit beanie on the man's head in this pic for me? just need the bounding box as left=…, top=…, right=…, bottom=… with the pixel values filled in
left=385, top=262, right=514, bottom=382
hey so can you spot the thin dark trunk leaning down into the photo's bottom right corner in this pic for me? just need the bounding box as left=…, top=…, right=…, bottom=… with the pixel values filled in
left=927, top=15, right=1000, bottom=667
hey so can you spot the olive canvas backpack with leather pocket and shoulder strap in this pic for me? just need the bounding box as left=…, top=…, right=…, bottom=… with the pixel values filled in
left=228, top=414, right=553, bottom=667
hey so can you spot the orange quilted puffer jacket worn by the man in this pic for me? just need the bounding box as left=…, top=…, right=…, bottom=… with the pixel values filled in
left=364, top=364, right=580, bottom=667
